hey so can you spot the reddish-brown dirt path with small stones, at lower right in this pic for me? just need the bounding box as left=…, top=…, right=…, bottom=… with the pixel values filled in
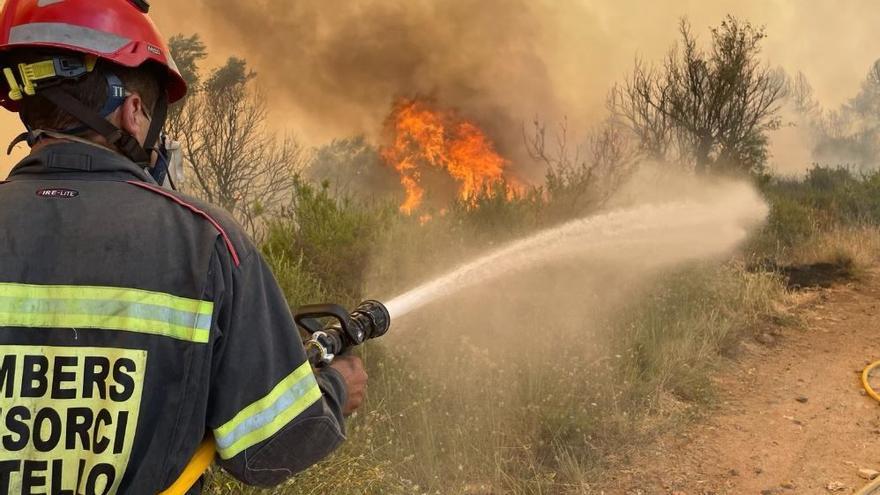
left=603, top=273, right=880, bottom=495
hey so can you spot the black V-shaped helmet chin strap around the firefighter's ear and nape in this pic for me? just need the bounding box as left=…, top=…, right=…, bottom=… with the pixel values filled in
left=40, top=85, right=168, bottom=167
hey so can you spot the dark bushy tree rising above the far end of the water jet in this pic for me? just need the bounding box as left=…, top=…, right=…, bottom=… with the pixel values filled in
left=609, top=16, right=786, bottom=173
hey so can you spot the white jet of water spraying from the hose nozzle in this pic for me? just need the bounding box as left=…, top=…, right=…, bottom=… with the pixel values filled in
left=386, top=183, right=768, bottom=321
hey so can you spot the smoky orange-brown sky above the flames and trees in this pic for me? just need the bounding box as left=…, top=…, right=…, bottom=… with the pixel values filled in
left=0, top=0, right=880, bottom=175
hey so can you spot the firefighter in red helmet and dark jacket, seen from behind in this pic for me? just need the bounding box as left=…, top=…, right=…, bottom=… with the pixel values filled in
left=0, top=0, right=367, bottom=495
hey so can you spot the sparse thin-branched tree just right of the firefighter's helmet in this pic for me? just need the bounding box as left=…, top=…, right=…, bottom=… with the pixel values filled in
left=169, top=35, right=308, bottom=236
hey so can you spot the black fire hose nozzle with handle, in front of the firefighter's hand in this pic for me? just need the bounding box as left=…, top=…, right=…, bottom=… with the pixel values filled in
left=293, top=301, right=391, bottom=366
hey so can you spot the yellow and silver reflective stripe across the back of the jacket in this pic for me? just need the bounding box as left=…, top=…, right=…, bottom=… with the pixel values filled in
left=0, top=283, right=214, bottom=343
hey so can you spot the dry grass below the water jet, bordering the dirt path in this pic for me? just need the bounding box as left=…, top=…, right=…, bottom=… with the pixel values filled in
left=207, top=263, right=785, bottom=495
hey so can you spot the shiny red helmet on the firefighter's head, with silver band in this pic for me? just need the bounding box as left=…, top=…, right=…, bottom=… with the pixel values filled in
left=0, top=0, right=186, bottom=111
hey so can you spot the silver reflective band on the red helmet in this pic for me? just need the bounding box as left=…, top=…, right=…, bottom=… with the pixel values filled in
left=9, top=22, right=131, bottom=53
